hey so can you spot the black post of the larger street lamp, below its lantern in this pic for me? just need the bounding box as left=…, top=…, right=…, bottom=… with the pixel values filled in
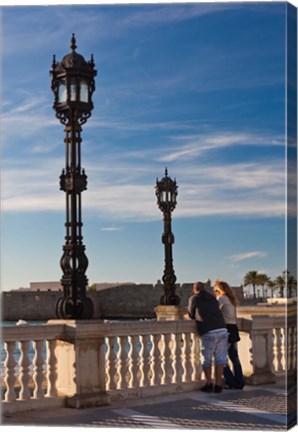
left=57, top=116, right=92, bottom=319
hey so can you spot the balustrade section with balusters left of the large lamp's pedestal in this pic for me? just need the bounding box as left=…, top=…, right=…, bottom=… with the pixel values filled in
left=1, top=325, right=64, bottom=413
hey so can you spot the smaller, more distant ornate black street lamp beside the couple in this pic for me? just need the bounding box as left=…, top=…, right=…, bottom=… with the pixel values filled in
left=155, top=168, right=180, bottom=306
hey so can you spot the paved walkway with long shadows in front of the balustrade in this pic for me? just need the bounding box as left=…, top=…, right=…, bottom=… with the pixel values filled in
left=2, top=385, right=297, bottom=431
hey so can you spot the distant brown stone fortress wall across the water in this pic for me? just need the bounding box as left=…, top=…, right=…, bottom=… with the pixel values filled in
left=1, top=283, right=243, bottom=321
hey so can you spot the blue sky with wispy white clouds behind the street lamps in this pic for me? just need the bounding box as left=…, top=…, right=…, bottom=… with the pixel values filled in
left=1, top=2, right=292, bottom=290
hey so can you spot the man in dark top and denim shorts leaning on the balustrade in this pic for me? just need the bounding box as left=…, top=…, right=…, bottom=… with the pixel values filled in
left=188, top=282, right=228, bottom=393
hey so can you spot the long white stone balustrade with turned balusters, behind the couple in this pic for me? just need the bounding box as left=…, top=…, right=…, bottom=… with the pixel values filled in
left=2, top=315, right=296, bottom=413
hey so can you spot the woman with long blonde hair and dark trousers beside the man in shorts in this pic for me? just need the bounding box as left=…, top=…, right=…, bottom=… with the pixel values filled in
left=213, top=280, right=244, bottom=389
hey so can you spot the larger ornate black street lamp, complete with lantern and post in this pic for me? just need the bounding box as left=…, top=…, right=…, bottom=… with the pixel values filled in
left=50, top=34, right=96, bottom=319
